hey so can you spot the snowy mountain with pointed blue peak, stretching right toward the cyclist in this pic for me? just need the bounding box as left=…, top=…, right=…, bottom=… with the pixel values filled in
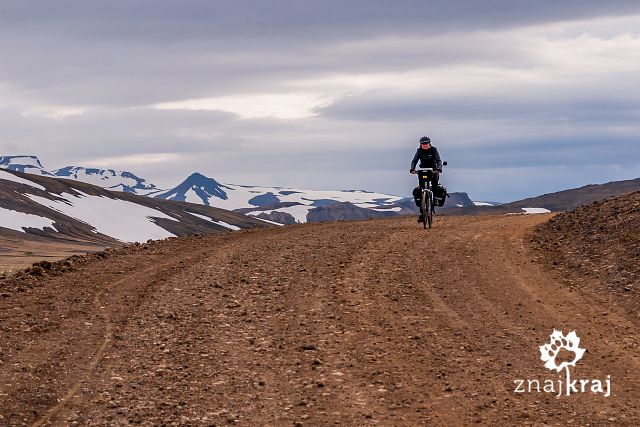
left=153, top=173, right=403, bottom=223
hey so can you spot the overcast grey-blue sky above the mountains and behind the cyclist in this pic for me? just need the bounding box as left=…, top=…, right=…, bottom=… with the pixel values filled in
left=0, top=0, right=640, bottom=201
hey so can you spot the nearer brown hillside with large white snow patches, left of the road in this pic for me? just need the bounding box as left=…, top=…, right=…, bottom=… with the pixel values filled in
left=0, top=170, right=267, bottom=244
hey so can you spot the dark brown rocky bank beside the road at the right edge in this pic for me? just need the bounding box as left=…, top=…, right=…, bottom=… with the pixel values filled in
left=533, top=191, right=640, bottom=310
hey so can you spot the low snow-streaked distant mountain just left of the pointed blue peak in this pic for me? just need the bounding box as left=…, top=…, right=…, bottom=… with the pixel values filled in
left=53, top=166, right=162, bottom=196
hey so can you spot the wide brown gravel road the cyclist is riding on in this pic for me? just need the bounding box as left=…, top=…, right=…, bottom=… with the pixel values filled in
left=0, top=216, right=640, bottom=426
